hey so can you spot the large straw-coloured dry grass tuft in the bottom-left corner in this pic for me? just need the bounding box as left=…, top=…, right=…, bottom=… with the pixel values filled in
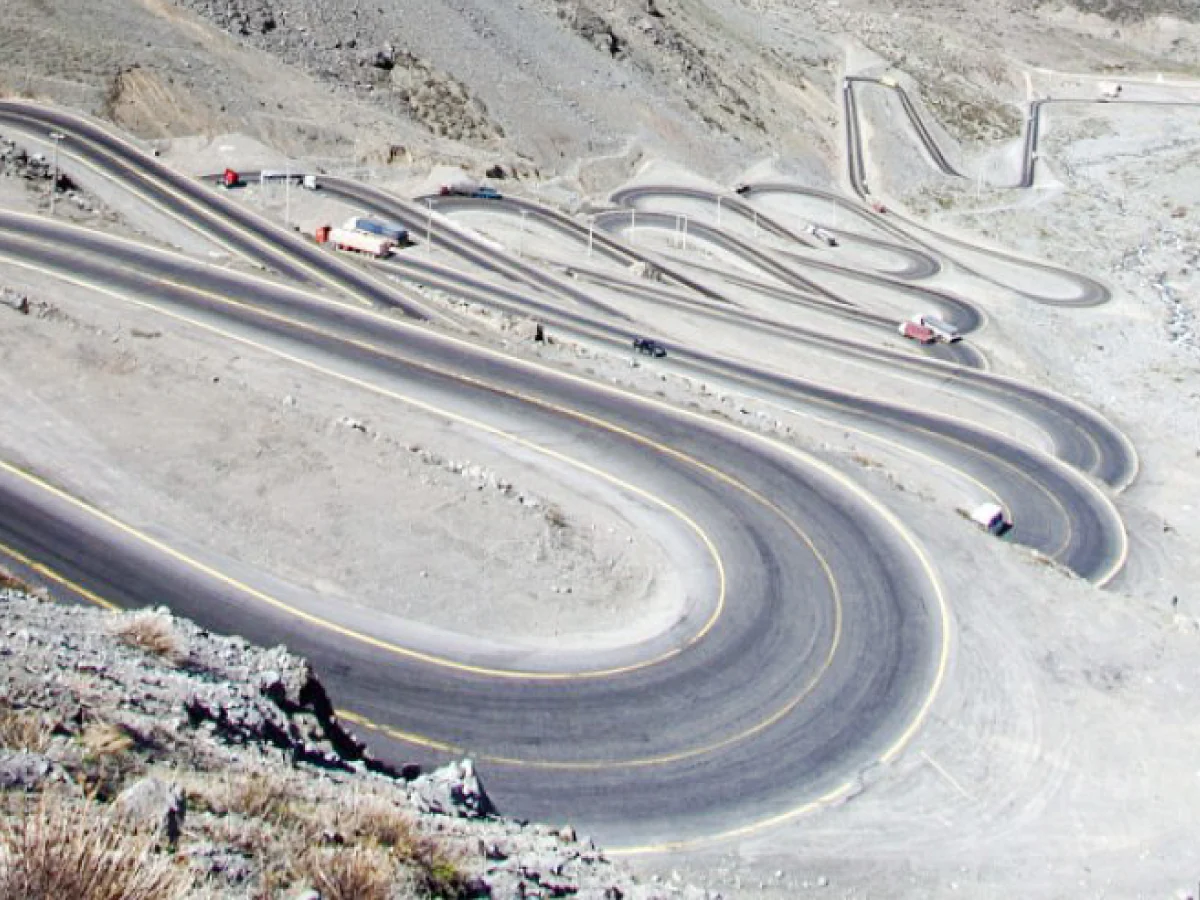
left=0, top=793, right=191, bottom=900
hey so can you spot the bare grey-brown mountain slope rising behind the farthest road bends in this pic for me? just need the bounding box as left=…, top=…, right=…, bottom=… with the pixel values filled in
left=7, top=0, right=1198, bottom=187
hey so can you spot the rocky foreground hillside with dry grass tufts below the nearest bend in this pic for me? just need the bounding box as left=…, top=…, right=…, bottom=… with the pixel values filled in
left=0, top=580, right=698, bottom=900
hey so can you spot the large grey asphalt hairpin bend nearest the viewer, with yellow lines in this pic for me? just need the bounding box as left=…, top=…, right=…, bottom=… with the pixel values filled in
left=0, top=214, right=942, bottom=840
